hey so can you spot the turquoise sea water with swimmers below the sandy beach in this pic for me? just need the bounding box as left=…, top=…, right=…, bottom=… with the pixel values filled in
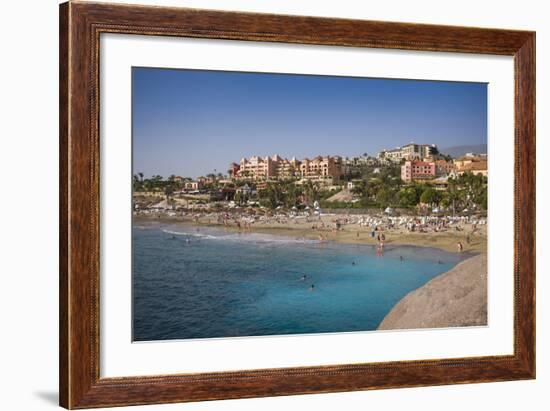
left=132, top=223, right=465, bottom=341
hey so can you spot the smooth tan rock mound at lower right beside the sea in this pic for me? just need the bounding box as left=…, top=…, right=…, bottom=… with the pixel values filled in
left=378, top=254, right=487, bottom=330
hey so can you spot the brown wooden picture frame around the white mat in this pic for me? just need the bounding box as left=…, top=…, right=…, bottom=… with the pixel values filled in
left=59, top=2, right=535, bottom=409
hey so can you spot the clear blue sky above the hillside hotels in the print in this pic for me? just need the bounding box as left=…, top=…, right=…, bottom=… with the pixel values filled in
left=132, top=67, right=487, bottom=177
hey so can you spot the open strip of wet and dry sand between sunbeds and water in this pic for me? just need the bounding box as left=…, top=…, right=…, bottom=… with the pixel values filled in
left=132, top=214, right=487, bottom=254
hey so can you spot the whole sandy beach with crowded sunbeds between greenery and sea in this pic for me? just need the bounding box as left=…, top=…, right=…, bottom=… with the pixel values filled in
left=134, top=212, right=487, bottom=253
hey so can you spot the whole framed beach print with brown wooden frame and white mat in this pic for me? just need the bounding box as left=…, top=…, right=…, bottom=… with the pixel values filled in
left=60, top=2, right=535, bottom=409
